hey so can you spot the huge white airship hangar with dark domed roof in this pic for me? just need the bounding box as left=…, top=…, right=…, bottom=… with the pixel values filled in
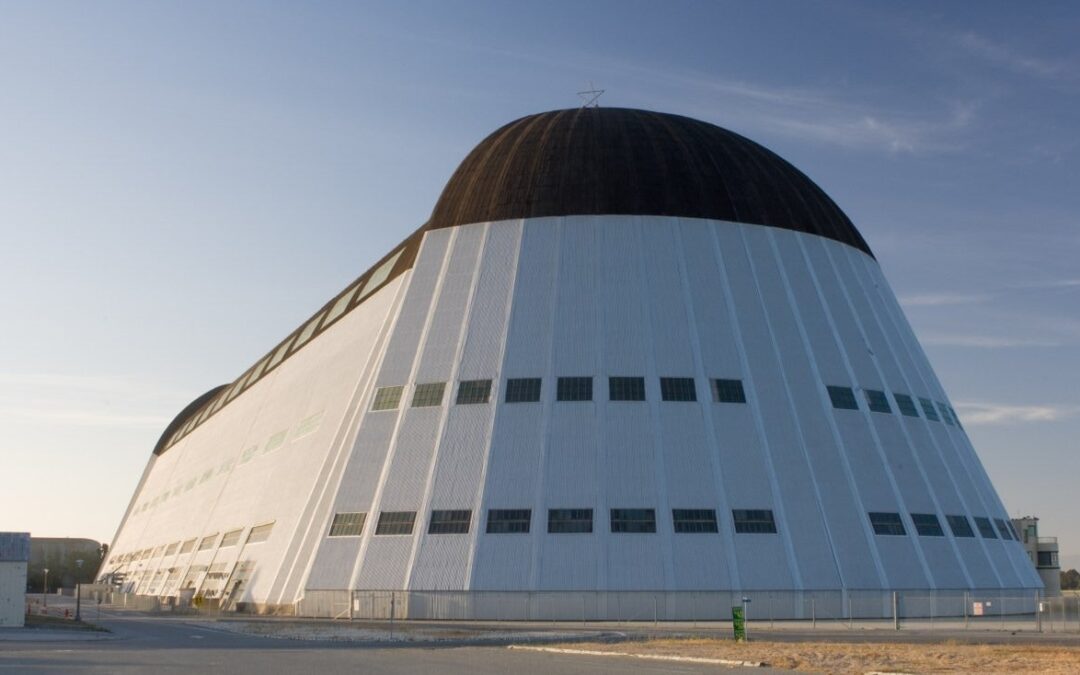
left=103, top=108, right=1042, bottom=619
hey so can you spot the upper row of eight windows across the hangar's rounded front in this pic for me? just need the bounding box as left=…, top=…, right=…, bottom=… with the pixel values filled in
left=372, top=377, right=746, bottom=410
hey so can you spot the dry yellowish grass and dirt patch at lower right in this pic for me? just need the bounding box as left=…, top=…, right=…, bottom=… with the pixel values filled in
left=557, top=639, right=1080, bottom=674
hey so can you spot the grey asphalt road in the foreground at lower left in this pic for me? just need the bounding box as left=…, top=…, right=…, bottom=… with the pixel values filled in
left=0, top=608, right=775, bottom=675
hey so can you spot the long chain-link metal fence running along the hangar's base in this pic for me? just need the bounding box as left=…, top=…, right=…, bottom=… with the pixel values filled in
left=90, top=584, right=1080, bottom=634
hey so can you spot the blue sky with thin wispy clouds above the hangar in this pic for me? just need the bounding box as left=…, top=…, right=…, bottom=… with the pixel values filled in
left=0, top=0, right=1080, bottom=565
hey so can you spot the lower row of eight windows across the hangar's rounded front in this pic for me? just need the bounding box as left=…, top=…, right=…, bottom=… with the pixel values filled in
left=328, top=509, right=777, bottom=537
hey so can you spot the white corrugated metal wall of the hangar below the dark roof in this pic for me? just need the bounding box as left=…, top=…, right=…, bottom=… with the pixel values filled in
left=101, top=216, right=1038, bottom=617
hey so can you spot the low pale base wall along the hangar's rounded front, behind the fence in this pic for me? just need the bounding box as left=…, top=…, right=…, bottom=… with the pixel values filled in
left=296, top=589, right=1039, bottom=621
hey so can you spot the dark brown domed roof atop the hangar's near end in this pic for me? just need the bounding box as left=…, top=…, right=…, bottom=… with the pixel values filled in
left=426, top=108, right=874, bottom=256
